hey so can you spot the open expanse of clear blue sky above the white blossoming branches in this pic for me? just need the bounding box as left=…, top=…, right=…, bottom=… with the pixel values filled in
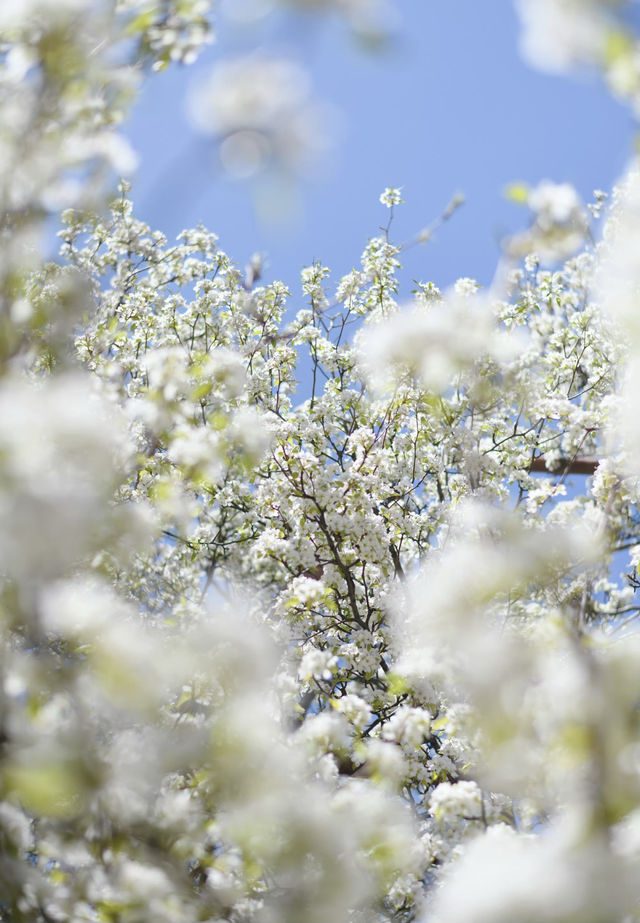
left=127, top=0, right=634, bottom=290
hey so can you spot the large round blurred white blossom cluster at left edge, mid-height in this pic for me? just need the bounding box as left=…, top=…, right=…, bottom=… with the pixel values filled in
left=0, top=375, right=131, bottom=579
